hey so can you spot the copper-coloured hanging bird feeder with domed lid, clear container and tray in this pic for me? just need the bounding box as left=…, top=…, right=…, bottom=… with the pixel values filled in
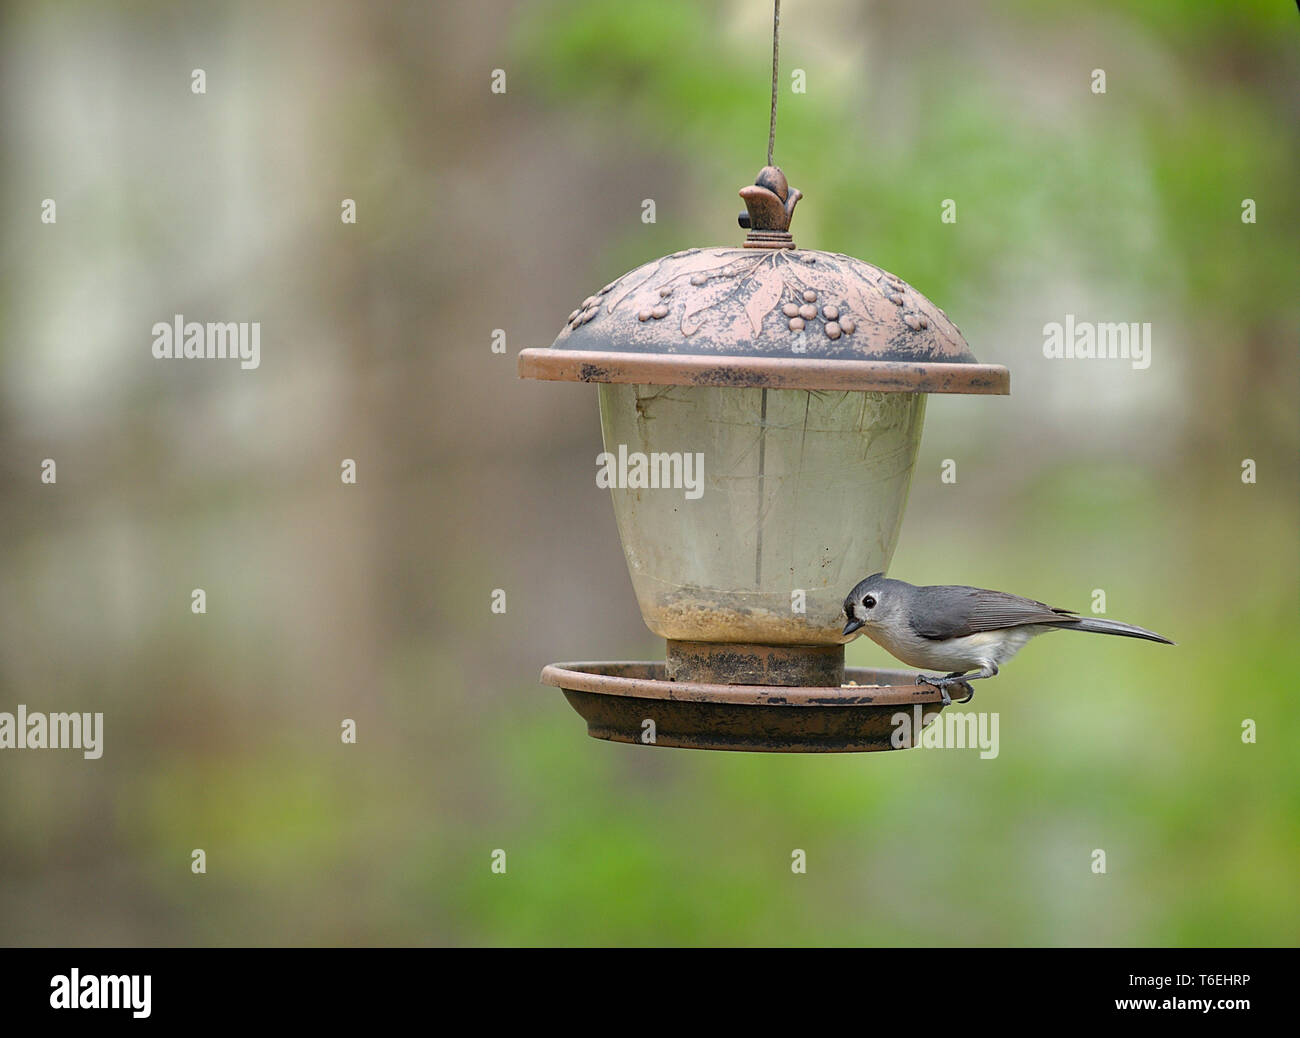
left=519, top=0, right=1010, bottom=752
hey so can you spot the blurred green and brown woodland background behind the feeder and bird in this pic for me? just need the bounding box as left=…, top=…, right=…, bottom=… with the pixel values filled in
left=0, top=0, right=1300, bottom=946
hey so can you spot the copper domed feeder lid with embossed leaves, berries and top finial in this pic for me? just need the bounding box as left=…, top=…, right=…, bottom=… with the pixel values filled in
left=519, top=166, right=1010, bottom=394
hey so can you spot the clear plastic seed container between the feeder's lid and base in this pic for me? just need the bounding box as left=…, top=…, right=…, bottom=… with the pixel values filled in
left=598, top=384, right=926, bottom=645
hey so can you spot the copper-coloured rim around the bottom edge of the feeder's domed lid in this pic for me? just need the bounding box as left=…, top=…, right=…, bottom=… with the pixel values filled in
left=519, top=347, right=1011, bottom=397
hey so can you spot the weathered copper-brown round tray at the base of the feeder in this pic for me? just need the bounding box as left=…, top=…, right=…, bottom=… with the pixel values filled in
left=542, top=663, right=971, bottom=753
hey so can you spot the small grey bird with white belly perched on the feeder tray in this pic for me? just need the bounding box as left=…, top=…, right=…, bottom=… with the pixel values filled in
left=844, top=574, right=1174, bottom=706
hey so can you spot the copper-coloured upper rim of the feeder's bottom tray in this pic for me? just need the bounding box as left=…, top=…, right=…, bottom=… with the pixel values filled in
left=541, top=661, right=959, bottom=706
